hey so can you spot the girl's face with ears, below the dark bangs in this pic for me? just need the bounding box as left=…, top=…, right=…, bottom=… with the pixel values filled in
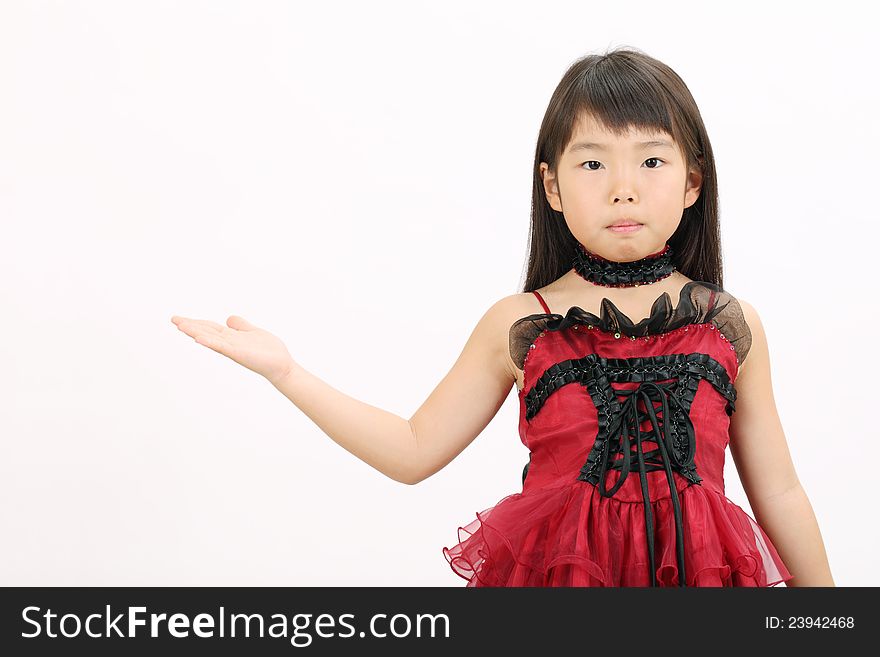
left=540, top=117, right=702, bottom=262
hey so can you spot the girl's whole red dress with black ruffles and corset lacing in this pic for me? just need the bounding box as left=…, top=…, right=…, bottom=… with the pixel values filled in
left=443, top=281, right=792, bottom=586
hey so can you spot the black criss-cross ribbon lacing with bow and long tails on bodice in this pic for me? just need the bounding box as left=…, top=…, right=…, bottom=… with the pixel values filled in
left=585, top=381, right=699, bottom=586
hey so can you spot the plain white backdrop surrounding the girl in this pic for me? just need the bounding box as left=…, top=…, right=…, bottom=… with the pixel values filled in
left=0, top=0, right=880, bottom=586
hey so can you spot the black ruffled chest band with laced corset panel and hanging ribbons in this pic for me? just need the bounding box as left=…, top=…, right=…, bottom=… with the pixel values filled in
left=523, top=353, right=736, bottom=586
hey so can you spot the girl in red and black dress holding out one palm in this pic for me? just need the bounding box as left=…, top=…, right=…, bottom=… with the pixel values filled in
left=172, top=49, right=833, bottom=586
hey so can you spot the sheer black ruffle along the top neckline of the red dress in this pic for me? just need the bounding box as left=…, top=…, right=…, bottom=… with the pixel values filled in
left=509, top=281, right=752, bottom=370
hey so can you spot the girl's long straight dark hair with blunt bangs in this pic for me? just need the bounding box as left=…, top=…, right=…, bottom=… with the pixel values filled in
left=523, top=47, right=723, bottom=292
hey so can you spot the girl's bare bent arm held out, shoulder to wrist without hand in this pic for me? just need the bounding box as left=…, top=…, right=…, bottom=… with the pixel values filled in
left=273, top=296, right=515, bottom=484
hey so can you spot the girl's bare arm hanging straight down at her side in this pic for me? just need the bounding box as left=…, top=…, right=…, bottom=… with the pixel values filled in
left=730, top=299, right=834, bottom=586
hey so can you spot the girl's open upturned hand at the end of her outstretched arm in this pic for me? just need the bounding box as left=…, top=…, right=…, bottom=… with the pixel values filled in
left=171, top=315, right=295, bottom=385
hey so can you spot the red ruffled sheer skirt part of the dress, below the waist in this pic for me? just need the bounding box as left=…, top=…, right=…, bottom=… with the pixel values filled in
left=443, top=481, right=792, bottom=587
